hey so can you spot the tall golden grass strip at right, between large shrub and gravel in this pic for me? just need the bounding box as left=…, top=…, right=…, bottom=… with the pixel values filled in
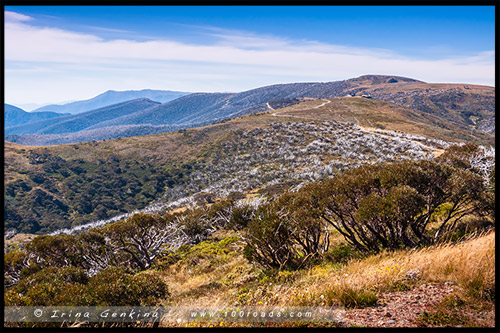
left=290, top=228, right=495, bottom=301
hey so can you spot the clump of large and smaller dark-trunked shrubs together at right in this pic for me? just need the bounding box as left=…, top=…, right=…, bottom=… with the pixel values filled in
left=245, top=150, right=494, bottom=269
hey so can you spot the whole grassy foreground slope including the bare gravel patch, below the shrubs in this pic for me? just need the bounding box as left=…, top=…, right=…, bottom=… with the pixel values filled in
left=150, top=228, right=495, bottom=327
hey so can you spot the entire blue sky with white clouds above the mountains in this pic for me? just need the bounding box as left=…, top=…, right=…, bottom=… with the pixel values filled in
left=5, top=6, right=495, bottom=105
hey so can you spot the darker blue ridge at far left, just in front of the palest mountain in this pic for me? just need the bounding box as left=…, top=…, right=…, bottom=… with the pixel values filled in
left=5, top=98, right=160, bottom=135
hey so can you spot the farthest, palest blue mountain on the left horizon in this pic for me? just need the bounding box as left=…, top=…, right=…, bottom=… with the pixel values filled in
left=33, top=89, right=189, bottom=114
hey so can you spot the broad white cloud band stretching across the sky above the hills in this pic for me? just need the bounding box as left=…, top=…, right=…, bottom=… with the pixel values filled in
left=5, top=12, right=495, bottom=103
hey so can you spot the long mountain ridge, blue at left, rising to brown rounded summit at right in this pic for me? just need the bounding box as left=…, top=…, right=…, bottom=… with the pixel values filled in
left=5, top=75, right=495, bottom=145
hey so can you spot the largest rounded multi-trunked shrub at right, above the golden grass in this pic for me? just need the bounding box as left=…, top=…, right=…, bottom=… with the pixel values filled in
left=318, top=160, right=487, bottom=252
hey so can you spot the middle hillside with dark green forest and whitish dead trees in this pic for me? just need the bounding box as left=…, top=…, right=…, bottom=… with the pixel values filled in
left=4, top=98, right=464, bottom=233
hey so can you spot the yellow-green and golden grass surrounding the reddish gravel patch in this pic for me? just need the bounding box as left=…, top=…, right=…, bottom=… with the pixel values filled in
left=151, top=231, right=495, bottom=327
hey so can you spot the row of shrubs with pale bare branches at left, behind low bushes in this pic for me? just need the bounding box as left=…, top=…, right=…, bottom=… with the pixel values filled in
left=4, top=205, right=234, bottom=288
